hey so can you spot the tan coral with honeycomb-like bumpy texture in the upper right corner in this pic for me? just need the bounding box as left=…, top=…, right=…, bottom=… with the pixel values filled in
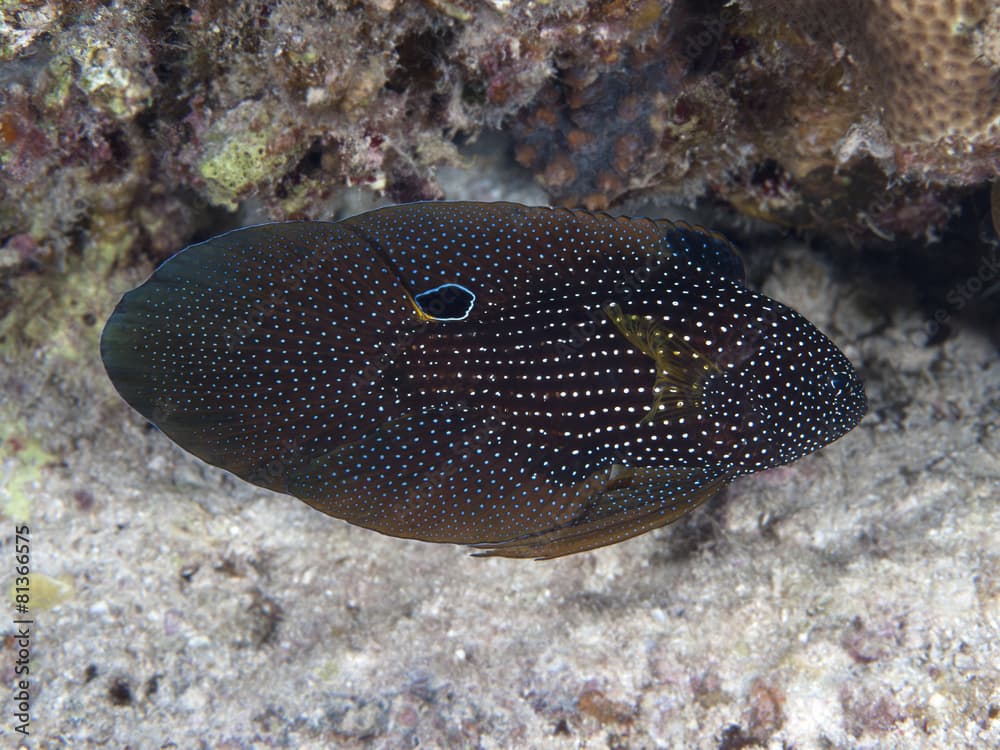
left=783, top=0, right=1000, bottom=185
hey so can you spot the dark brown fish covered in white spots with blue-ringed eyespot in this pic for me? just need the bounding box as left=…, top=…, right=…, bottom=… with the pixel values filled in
left=101, top=202, right=866, bottom=558
